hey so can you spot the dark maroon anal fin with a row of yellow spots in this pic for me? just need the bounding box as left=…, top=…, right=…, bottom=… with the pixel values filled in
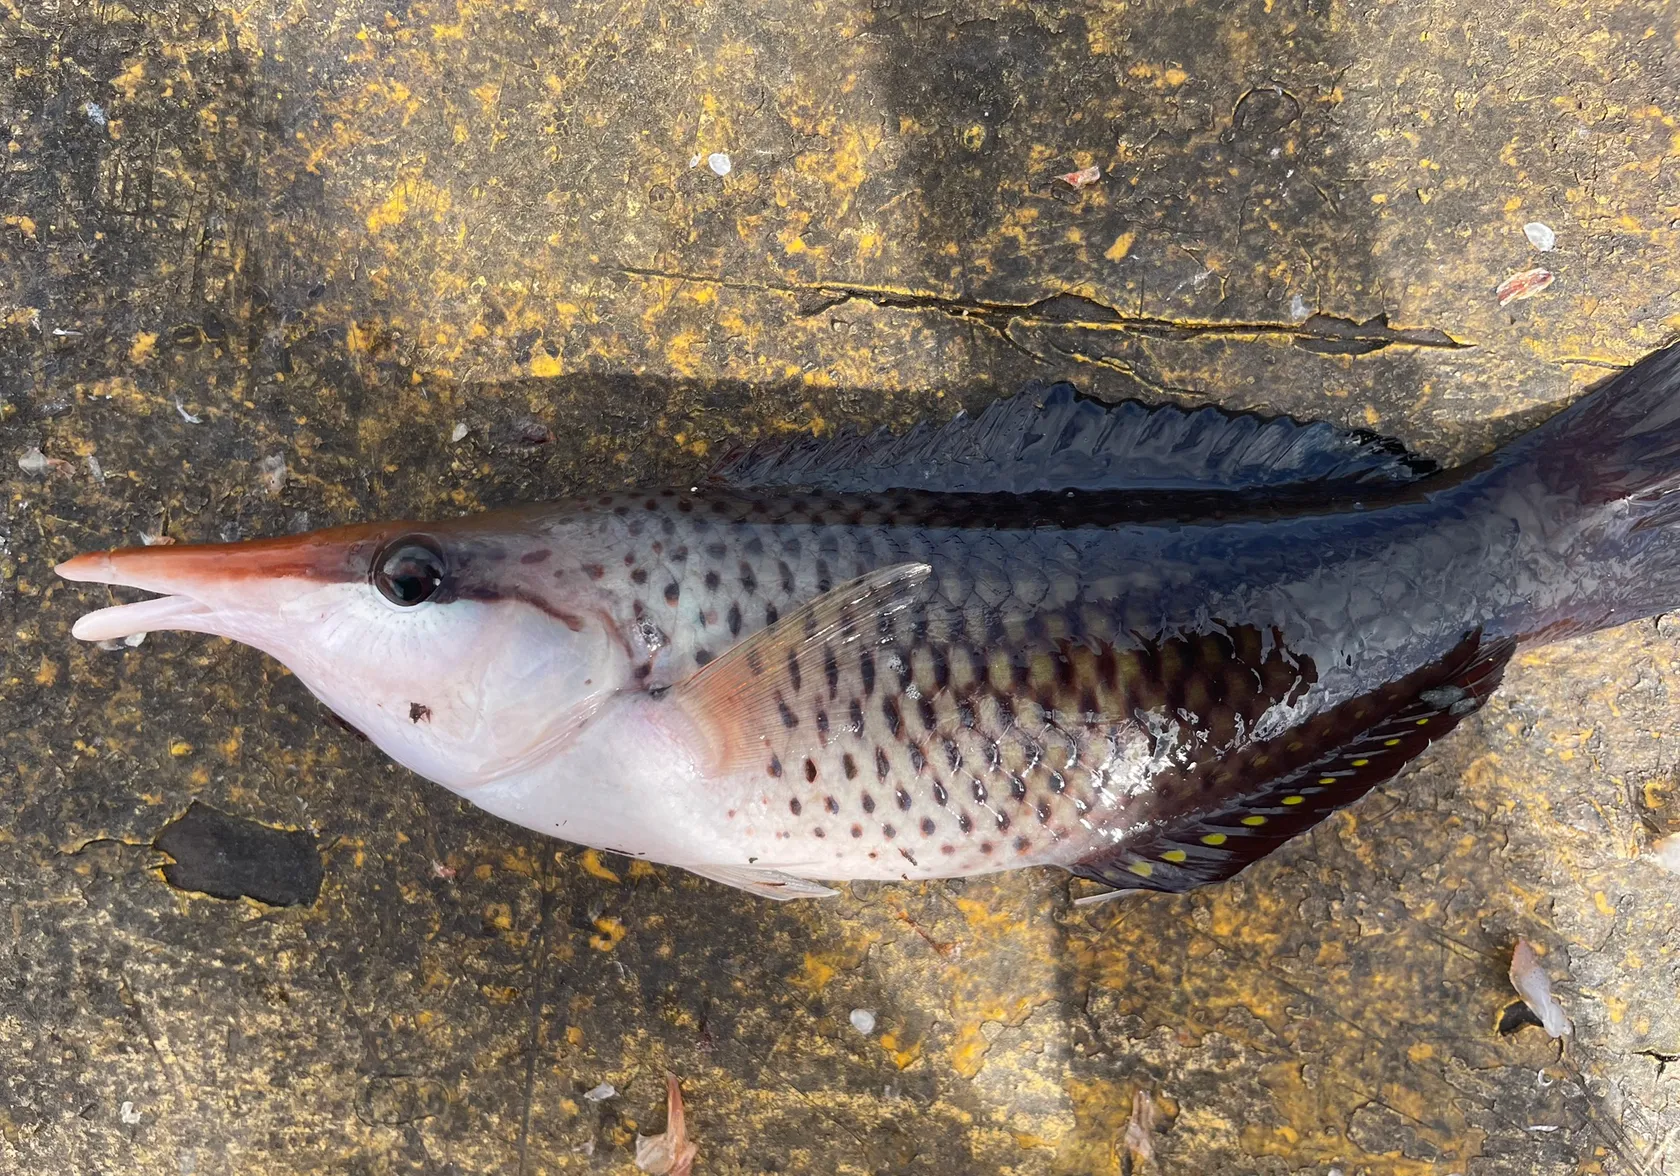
left=1070, top=633, right=1515, bottom=900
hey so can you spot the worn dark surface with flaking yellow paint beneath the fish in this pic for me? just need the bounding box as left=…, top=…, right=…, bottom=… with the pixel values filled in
left=0, top=0, right=1680, bottom=1176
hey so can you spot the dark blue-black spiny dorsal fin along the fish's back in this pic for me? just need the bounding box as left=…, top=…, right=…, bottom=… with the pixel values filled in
left=712, top=383, right=1435, bottom=494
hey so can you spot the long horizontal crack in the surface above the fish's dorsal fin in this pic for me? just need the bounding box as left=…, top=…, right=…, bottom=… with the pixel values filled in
left=620, top=265, right=1475, bottom=354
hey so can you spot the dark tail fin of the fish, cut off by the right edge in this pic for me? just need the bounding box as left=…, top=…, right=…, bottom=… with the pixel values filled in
left=1499, top=344, right=1680, bottom=635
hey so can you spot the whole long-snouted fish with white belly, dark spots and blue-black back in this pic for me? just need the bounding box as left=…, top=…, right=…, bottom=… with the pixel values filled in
left=59, top=349, right=1680, bottom=897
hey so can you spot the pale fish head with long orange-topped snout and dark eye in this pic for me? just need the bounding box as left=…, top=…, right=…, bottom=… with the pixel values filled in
left=57, top=514, right=630, bottom=791
